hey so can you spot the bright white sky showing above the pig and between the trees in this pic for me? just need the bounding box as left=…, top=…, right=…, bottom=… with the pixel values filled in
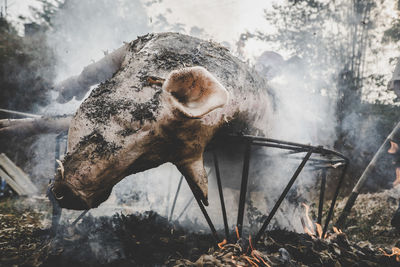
left=0, top=0, right=397, bottom=101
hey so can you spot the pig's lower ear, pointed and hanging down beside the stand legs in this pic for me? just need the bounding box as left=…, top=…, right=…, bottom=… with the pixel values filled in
left=177, top=157, right=208, bottom=206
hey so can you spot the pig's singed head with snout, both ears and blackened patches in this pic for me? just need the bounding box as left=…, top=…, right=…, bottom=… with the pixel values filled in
left=50, top=66, right=229, bottom=210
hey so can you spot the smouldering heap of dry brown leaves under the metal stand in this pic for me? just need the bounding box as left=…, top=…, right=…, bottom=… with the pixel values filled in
left=167, top=230, right=398, bottom=266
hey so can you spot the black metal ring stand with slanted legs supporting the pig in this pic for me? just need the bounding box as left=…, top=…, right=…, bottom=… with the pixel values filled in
left=49, top=135, right=349, bottom=248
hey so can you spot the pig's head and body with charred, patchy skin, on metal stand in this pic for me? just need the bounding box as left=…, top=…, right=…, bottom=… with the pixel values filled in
left=51, top=33, right=271, bottom=209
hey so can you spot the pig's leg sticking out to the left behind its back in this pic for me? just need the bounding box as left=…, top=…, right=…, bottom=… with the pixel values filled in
left=55, top=45, right=128, bottom=103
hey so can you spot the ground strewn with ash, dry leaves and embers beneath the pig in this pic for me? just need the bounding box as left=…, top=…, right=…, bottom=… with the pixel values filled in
left=0, top=187, right=400, bottom=267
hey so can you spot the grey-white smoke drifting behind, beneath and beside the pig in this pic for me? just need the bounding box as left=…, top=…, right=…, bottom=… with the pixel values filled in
left=30, top=0, right=344, bottom=234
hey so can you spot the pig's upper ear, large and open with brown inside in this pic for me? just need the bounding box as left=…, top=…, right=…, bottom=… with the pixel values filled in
left=163, top=67, right=228, bottom=118
